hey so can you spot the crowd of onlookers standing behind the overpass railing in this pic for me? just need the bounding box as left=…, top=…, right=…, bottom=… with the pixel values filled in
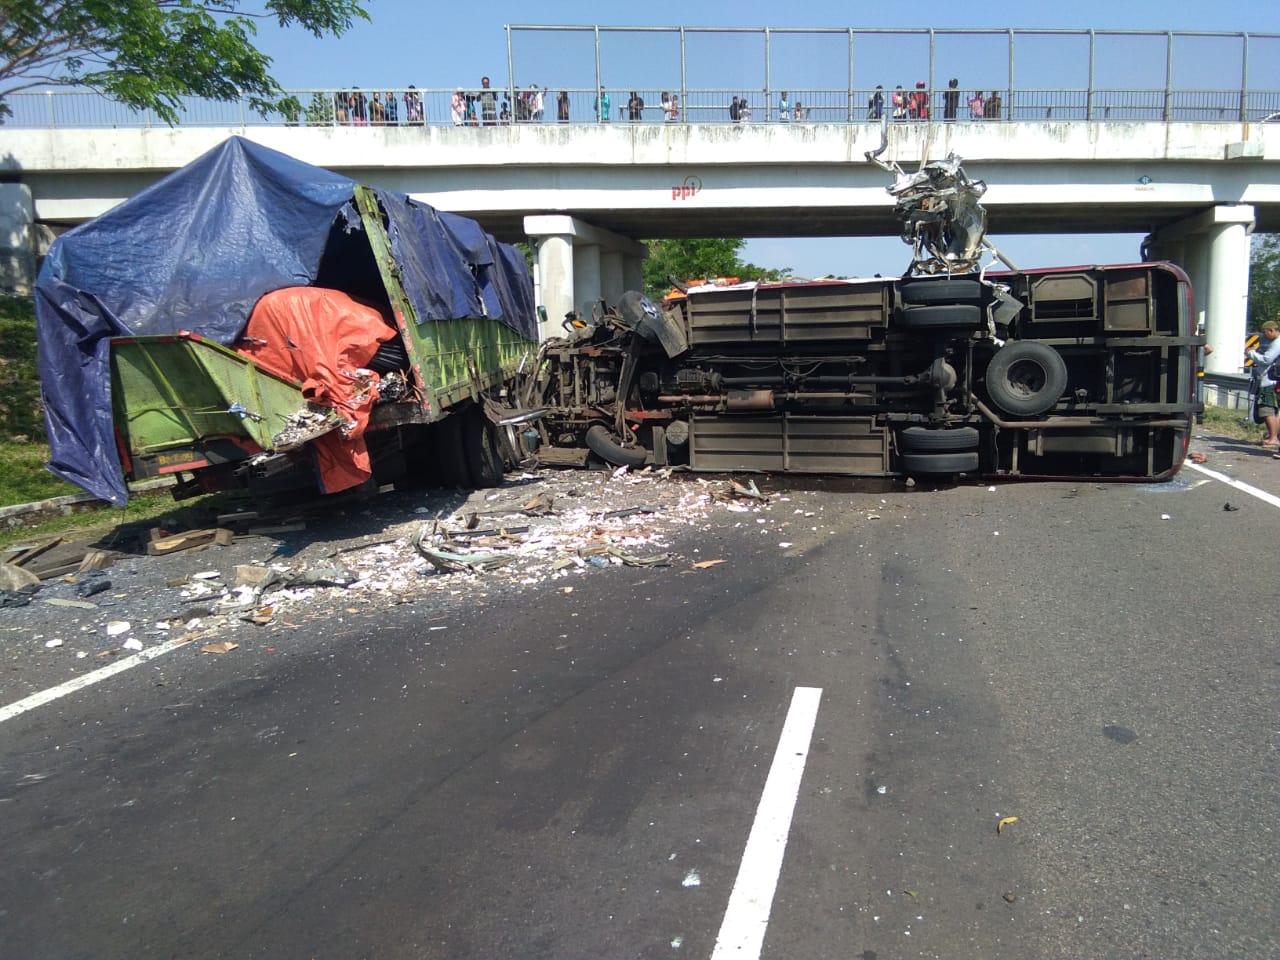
left=333, top=77, right=1004, bottom=127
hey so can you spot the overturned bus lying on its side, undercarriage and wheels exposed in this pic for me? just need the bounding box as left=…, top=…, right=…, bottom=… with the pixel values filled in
left=521, top=155, right=1203, bottom=480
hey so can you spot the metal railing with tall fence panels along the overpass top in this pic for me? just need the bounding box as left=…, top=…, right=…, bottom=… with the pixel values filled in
left=5, top=24, right=1280, bottom=128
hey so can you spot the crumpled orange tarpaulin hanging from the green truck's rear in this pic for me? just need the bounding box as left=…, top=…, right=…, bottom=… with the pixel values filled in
left=236, top=287, right=398, bottom=493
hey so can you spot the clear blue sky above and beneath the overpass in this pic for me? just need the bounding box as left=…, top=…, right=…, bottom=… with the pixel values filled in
left=259, top=0, right=1280, bottom=276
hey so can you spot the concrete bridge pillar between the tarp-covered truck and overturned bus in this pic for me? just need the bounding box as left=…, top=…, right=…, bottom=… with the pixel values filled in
left=525, top=214, right=649, bottom=339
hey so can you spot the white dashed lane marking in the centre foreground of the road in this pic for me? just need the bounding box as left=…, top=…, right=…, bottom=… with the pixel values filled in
left=712, top=686, right=822, bottom=960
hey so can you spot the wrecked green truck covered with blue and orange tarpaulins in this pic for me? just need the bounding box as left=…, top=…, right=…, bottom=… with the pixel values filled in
left=36, top=137, right=538, bottom=506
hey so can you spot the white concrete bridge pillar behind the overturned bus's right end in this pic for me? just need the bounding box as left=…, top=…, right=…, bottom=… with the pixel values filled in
left=1149, top=204, right=1253, bottom=374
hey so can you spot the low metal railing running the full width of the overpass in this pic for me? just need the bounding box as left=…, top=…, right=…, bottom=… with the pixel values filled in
left=4, top=86, right=1280, bottom=129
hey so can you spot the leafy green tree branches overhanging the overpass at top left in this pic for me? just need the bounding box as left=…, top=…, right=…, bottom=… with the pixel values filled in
left=0, top=0, right=369, bottom=124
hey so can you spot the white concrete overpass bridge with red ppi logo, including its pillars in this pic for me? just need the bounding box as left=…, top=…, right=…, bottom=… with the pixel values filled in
left=0, top=120, right=1280, bottom=369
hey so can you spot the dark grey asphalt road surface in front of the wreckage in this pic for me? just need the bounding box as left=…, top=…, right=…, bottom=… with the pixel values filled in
left=0, top=440, right=1280, bottom=960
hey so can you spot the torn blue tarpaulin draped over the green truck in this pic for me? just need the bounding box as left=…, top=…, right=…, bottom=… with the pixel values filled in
left=36, top=137, right=538, bottom=506
